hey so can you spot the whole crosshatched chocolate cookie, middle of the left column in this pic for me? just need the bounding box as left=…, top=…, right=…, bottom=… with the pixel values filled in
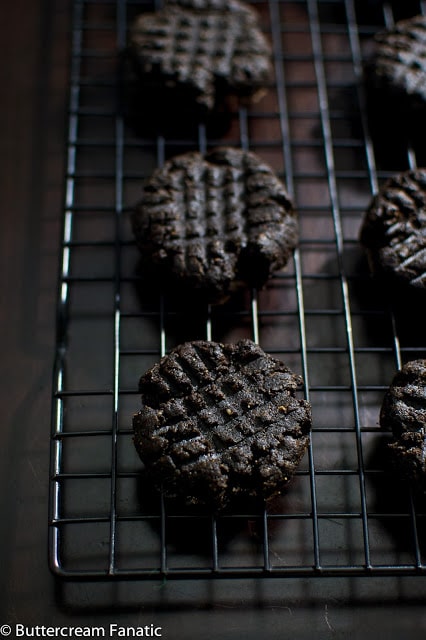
left=132, top=148, right=298, bottom=302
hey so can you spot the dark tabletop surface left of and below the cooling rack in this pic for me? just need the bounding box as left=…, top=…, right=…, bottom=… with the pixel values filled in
left=0, top=0, right=426, bottom=639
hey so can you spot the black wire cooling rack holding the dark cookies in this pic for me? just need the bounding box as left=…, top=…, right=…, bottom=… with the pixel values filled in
left=49, top=0, right=426, bottom=579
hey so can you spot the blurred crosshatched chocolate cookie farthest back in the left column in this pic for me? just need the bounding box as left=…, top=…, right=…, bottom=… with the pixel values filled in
left=127, top=0, right=272, bottom=117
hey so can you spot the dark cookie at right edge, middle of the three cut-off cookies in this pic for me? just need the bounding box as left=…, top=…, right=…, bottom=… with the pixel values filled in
left=360, top=169, right=426, bottom=293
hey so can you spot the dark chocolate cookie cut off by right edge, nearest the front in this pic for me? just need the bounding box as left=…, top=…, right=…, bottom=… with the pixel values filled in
left=380, top=360, right=426, bottom=492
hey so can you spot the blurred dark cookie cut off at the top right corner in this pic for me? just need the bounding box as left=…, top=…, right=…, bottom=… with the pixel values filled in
left=366, top=15, right=426, bottom=111
